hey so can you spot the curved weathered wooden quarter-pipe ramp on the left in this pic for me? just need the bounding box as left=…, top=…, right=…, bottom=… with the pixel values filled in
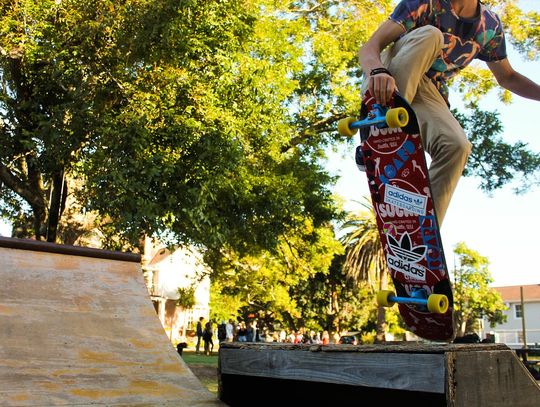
left=0, top=238, right=224, bottom=407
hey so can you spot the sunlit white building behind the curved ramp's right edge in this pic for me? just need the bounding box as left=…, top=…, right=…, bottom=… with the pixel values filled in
left=142, top=239, right=210, bottom=342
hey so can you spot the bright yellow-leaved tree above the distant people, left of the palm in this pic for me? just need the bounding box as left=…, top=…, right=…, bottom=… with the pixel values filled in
left=206, top=222, right=342, bottom=329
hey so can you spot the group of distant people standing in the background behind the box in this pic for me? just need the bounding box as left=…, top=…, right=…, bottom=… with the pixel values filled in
left=195, top=317, right=340, bottom=355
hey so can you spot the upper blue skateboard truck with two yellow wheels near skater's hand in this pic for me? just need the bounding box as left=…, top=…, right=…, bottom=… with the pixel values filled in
left=338, top=103, right=409, bottom=137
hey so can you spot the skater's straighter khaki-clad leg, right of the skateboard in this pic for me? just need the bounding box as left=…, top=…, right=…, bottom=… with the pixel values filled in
left=412, top=76, right=471, bottom=226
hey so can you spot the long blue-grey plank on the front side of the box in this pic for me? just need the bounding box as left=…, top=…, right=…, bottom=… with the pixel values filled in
left=220, top=346, right=445, bottom=393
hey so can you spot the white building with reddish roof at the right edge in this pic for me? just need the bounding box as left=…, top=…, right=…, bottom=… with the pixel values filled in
left=483, top=284, right=540, bottom=348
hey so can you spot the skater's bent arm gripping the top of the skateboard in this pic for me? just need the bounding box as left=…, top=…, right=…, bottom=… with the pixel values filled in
left=358, top=20, right=405, bottom=105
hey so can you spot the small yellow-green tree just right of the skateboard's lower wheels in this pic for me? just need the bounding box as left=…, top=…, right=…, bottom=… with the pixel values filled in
left=454, top=242, right=507, bottom=337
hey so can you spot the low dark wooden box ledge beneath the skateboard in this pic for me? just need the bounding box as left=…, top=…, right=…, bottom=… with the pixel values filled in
left=219, top=342, right=540, bottom=407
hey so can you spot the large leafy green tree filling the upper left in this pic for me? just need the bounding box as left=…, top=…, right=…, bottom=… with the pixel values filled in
left=0, top=0, right=335, bottom=252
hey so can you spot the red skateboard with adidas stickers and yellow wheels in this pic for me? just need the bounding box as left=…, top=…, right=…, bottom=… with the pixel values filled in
left=338, top=91, right=454, bottom=341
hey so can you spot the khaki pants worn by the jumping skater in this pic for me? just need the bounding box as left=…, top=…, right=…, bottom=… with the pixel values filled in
left=363, top=26, right=471, bottom=225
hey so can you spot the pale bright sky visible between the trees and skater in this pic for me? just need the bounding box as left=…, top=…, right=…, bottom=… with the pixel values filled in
left=328, top=1, right=540, bottom=286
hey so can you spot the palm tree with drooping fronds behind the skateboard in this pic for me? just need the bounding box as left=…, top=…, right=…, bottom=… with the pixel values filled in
left=340, top=198, right=388, bottom=342
